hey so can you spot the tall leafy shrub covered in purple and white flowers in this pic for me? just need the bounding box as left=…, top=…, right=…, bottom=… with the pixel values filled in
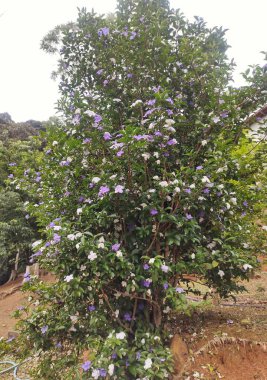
left=17, top=0, right=266, bottom=379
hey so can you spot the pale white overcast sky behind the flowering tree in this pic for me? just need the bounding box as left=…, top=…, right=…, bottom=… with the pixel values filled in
left=0, top=0, right=267, bottom=122
